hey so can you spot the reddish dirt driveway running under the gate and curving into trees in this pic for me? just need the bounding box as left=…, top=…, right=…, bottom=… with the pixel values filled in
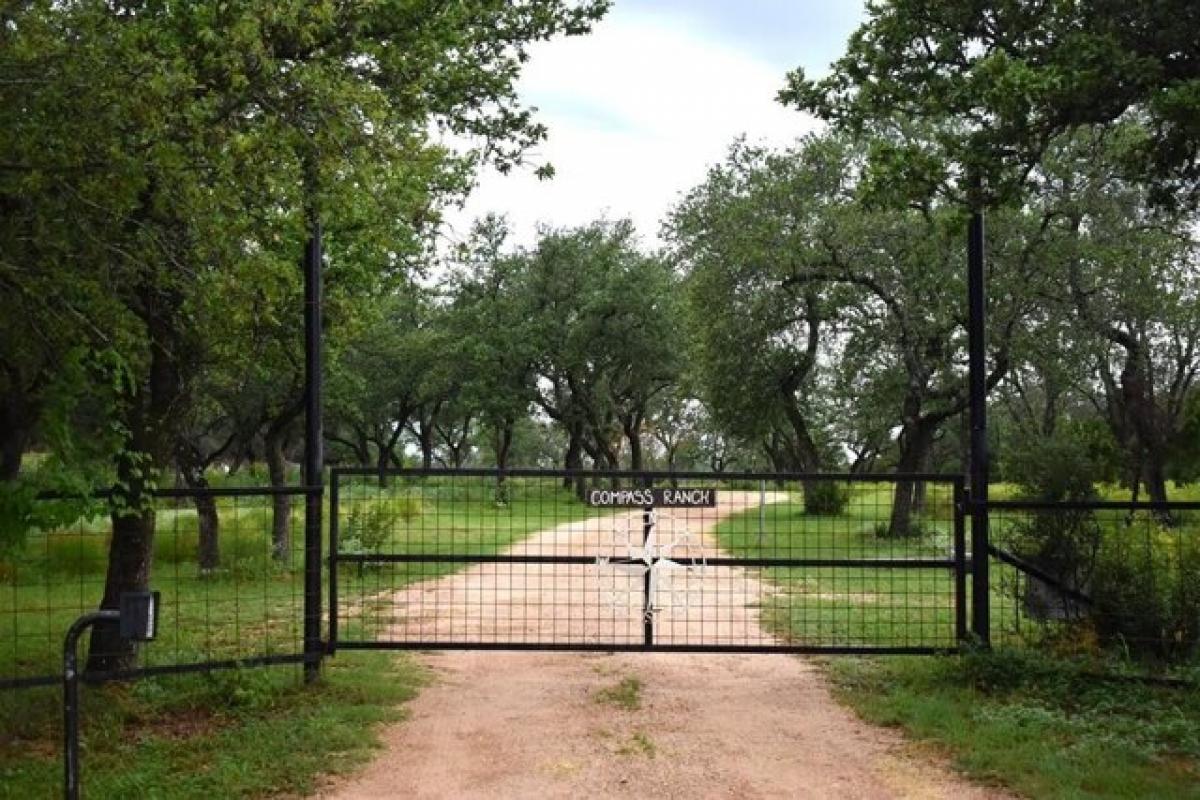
left=323, top=492, right=1002, bottom=800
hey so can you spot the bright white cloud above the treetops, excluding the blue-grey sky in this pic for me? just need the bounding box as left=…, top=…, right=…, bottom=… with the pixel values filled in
left=448, top=7, right=816, bottom=243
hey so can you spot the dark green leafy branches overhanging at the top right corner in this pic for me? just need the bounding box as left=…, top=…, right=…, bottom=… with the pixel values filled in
left=779, top=0, right=1200, bottom=204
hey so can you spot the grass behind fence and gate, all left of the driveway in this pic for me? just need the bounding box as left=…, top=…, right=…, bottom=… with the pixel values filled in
left=0, top=480, right=606, bottom=686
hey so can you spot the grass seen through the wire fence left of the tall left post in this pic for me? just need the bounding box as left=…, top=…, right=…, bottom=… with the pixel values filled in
left=0, top=499, right=304, bottom=686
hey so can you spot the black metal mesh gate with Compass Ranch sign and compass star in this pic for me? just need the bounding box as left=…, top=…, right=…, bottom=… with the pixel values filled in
left=329, top=469, right=967, bottom=654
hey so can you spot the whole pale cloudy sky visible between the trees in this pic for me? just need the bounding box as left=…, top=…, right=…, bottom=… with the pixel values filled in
left=446, top=0, right=863, bottom=247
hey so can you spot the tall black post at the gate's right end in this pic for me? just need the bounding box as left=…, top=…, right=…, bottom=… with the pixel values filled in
left=967, top=199, right=991, bottom=646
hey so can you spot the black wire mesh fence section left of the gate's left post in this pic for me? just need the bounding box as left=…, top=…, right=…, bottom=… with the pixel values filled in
left=0, top=487, right=307, bottom=688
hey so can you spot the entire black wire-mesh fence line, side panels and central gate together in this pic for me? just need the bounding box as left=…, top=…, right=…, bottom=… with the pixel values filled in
left=0, top=470, right=1200, bottom=690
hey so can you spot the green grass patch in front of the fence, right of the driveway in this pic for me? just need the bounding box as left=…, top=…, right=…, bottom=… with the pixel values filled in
left=826, top=650, right=1200, bottom=800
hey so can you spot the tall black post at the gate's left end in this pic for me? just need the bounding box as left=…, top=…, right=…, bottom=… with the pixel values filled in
left=304, top=222, right=325, bottom=682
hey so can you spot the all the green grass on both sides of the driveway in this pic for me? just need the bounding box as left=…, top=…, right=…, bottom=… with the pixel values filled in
left=0, top=479, right=1200, bottom=798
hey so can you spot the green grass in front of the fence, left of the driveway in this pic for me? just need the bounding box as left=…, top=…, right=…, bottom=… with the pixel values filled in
left=0, top=654, right=424, bottom=800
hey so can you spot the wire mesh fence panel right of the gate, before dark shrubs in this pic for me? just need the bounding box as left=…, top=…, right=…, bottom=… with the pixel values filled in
left=989, top=501, right=1200, bottom=662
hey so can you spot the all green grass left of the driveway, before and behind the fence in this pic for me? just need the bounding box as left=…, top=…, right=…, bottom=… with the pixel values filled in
left=0, top=480, right=593, bottom=799
